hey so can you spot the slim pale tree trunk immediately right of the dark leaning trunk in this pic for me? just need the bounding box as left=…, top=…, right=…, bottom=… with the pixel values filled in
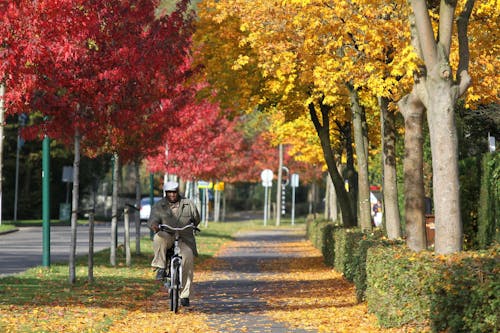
left=348, top=85, right=372, bottom=231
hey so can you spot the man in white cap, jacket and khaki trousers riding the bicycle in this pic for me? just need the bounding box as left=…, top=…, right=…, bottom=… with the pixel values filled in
left=148, top=182, right=200, bottom=306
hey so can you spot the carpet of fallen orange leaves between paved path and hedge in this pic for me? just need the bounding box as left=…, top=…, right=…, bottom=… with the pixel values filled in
left=259, top=235, right=428, bottom=333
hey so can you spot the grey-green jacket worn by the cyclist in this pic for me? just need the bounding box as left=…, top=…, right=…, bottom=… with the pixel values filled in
left=148, top=197, right=200, bottom=256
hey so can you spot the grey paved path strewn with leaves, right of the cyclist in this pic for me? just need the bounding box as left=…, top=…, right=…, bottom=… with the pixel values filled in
left=193, top=229, right=313, bottom=333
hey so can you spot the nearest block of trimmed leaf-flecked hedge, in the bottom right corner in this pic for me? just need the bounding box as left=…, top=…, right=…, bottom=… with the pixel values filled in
left=366, top=246, right=500, bottom=333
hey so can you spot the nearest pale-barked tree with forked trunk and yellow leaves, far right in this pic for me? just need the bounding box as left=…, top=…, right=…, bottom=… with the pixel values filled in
left=400, top=0, right=499, bottom=253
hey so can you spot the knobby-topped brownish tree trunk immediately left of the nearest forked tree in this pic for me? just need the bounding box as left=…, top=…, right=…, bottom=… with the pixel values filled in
left=398, top=93, right=427, bottom=251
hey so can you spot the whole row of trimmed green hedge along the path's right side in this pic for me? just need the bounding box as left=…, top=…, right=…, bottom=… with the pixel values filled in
left=307, top=214, right=500, bottom=333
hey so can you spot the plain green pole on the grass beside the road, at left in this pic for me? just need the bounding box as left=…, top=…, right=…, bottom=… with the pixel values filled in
left=42, top=135, right=50, bottom=267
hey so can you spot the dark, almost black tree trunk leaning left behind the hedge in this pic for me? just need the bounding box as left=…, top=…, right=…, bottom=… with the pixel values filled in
left=309, top=103, right=356, bottom=227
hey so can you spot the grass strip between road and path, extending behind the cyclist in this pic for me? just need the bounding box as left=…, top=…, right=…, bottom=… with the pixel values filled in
left=0, top=220, right=303, bottom=333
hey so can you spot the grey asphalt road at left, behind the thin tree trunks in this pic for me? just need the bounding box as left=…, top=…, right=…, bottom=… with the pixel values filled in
left=0, top=222, right=149, bottom=276
